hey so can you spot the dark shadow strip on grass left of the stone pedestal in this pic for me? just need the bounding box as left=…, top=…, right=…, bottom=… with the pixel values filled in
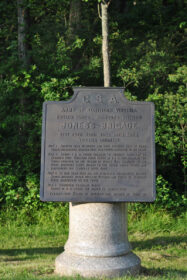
left=0, top=247, right=64, bottom=260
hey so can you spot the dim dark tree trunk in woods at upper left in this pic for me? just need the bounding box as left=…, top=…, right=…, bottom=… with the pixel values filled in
left=17, top=0, right=28, bottom=67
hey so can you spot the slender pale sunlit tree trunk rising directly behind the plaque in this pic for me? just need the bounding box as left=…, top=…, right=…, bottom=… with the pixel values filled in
left=101, top=2, right=110, bottom=87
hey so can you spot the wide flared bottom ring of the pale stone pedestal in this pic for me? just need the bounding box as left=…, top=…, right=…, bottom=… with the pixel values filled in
left=55, top=252, right=140, bottom=277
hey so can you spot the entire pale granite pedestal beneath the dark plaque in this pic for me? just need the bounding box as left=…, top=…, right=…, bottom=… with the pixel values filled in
left=55, top=203, right=140, bottom=277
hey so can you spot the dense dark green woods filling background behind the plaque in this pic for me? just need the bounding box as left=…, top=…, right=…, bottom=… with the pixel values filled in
left=0, top=0, right=187, bottom=217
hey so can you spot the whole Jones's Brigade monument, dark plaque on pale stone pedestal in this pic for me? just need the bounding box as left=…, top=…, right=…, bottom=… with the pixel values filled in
left=40, top=88, right=155, bottom=277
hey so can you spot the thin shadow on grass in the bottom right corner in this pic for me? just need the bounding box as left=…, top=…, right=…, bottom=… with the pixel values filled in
left=139, top=267, right=187, bottom=279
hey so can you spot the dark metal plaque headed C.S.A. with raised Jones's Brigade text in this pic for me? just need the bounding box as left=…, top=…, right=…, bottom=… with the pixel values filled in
left=40, top=88, right=155, bottom=202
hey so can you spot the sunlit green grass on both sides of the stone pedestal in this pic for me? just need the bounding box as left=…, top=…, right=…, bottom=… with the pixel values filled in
left=0, top=209, right=187, bottom=280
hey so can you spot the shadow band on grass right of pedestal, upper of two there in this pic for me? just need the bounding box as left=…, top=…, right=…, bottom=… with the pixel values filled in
left=131, top=236, right=187, bottom=250
